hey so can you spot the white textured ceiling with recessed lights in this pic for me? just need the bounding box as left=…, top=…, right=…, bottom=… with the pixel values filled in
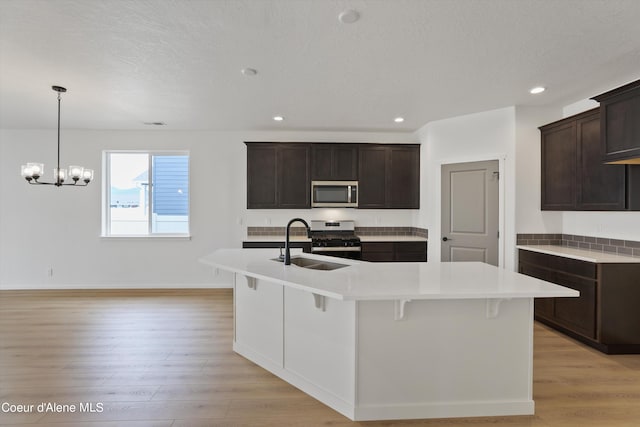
left=0, top=0, right=640, bottom=131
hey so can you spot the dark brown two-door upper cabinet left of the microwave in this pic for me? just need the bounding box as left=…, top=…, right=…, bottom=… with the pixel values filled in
left=246, top=142, right=311, bottom=209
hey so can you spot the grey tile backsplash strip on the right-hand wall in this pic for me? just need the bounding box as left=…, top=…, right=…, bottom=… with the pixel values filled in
left=516, top=234, right=640, bottom=257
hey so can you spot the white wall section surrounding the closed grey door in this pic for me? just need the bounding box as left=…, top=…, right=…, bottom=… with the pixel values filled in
left=417, top=107, right=516, bottom=269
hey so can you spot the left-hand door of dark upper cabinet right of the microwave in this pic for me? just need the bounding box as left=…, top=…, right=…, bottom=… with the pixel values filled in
left=358, top=145, right=387, bottom=209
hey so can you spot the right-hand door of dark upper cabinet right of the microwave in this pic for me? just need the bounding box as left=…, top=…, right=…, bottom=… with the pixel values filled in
left=387, top=146, right=420, bottom=209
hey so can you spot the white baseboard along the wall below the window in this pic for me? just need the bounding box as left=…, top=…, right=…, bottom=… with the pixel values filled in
left=0, top=283, right=233, bottom=291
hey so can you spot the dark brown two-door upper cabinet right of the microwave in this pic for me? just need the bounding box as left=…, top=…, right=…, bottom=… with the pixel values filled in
left=358, top=144, right=420, bottom=209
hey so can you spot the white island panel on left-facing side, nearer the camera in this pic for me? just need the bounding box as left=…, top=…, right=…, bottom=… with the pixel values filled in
left=284, top=287, right=356, bottom=417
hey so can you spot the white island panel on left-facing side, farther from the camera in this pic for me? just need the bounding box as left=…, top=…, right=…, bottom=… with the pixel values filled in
left=233, top=274, right=284, bottom=371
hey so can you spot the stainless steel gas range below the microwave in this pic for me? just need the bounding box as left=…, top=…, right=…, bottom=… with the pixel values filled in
left=311, top=220, right=361, bottom=259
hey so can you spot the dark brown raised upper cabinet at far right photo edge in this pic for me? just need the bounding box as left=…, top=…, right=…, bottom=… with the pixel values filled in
left=592, top=80, right=640, bottom=165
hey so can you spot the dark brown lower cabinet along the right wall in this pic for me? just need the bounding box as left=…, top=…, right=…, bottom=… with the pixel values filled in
left=518, top=249, right=640, bottom=354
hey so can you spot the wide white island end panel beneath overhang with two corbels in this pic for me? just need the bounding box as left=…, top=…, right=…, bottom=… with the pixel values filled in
left=355, top=298, right=534, bottom=420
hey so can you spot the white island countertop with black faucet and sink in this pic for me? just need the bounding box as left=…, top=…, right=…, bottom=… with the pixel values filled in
left=200, top=249, right=579, bottom=300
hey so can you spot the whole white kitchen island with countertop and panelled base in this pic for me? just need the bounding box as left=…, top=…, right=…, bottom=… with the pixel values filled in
left=200, top=249, right=578, bottom=420
